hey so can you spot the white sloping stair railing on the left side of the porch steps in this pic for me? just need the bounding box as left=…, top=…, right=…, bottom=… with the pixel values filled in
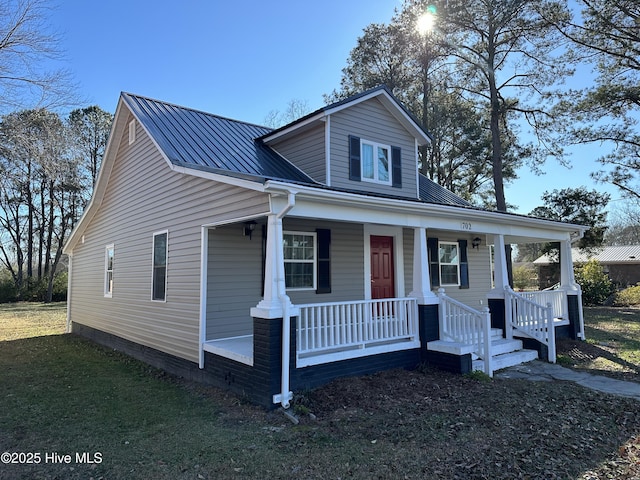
left=438, top=288, right=493, bottom=376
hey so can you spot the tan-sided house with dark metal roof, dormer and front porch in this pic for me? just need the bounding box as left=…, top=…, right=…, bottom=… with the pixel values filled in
left=65, top=87, right=584, bottom=407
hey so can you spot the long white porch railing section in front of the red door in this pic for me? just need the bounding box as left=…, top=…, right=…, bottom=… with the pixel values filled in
left=296, top=298, right=420, bottom=366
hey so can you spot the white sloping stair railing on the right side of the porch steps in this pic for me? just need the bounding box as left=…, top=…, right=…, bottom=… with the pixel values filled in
left=504, top=286, right=556, bottom=363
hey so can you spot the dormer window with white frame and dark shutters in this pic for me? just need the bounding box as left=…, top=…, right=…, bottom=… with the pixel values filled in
left=349, top=135, right=402, bottom=188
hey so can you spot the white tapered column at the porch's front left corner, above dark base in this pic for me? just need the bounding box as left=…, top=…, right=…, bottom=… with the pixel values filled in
left=251, top=214, right=295, bottom=318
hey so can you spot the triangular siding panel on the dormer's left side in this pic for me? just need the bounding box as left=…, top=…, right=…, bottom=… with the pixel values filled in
left=271, top=124, right=327, bottom=183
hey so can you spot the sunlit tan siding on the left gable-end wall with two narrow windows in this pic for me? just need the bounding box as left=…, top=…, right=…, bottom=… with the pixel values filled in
left=70, top=113, right=268, bottom=361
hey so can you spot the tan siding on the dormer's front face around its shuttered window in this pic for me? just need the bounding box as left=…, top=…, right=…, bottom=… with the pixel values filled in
left=331, top=98, right=417, bottom=198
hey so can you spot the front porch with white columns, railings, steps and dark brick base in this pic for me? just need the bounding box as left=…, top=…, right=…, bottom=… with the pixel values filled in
left=200, top=198, right=582, bottom=406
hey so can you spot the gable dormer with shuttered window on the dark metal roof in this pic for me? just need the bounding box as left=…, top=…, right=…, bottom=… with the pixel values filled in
left=263, top=87, right=429, bottom=199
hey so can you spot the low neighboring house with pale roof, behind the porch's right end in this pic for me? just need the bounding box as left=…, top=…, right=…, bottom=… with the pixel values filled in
left=533, top=245, right=640, bottom=287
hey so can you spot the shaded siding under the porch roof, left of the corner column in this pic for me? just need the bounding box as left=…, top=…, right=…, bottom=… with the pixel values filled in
left=206, top=221, right=264, bottom=340
